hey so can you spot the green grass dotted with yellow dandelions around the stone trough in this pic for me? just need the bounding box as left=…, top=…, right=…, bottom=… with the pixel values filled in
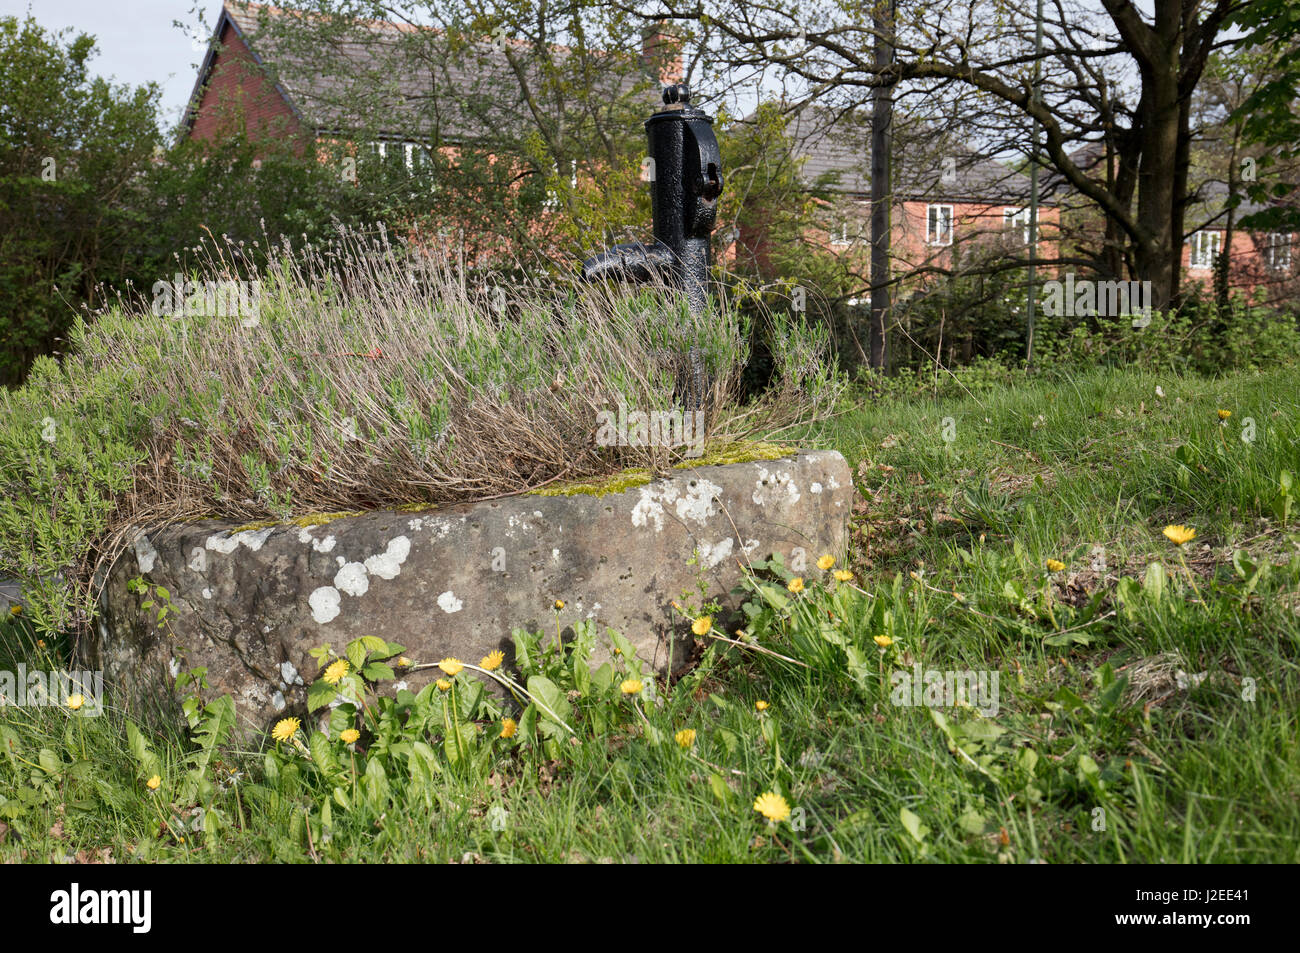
left=0, top=358, right=1300, bottom=863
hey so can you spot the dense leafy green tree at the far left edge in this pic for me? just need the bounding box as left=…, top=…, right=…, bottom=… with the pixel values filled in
left=0, top=17, right=161, bottom=385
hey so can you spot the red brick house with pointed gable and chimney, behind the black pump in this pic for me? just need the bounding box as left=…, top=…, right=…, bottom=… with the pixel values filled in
left=183, top=0, right=683, bottom=210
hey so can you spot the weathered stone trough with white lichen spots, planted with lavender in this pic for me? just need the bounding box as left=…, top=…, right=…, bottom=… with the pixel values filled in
left=94, top=451, right=853, bottom=727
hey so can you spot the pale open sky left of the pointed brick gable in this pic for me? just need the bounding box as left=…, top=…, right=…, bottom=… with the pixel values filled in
left=0, top=0, right=221, bottom=129
